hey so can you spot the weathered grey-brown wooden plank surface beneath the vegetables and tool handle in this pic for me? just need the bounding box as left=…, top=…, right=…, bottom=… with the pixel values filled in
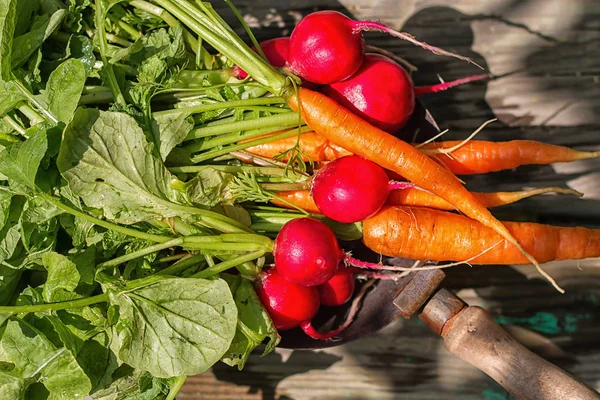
left=178, top=0, right=600, bottom=400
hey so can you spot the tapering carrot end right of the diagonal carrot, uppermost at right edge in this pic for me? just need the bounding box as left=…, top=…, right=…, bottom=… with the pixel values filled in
left=419, top=140, right=600, bottom=175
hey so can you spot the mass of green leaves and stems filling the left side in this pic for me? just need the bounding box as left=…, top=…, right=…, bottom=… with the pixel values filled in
left=0, top=0, right=326, bottom=400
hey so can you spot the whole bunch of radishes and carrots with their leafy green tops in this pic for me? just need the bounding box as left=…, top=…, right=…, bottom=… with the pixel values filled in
left=0, top=0, right=600, bottom=400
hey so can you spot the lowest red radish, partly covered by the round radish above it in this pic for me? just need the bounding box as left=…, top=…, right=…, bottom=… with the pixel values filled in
left=256, top=269, right=319, bottom=331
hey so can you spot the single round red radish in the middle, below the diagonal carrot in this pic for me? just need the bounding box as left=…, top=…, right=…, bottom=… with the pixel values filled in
left=311, top=155, right=414, bottom=223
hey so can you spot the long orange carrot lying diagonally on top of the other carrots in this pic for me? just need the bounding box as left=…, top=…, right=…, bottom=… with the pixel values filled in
left=286, top=87, right=564, bottom=292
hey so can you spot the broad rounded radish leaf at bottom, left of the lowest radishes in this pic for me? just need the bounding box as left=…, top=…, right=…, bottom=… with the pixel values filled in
left=109, top=277, right=237, bottom=378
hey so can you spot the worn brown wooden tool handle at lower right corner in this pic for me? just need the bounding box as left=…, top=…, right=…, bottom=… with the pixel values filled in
left=441, top=307, right=600, bottom=400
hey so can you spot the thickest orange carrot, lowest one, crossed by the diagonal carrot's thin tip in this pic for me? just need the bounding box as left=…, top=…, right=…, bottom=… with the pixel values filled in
left=363, top=207, right=600, bottom=264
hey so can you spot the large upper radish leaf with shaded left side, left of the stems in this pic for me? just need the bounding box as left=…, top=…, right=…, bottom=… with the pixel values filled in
left=57, top=108, right=190, bottom=223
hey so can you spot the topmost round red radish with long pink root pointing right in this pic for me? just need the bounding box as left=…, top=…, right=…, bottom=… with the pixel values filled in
left=286, top=11, right=473, bottom=84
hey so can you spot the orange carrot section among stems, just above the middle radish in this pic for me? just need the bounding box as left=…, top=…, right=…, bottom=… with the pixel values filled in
left=246, top=132, right=350, bottom=161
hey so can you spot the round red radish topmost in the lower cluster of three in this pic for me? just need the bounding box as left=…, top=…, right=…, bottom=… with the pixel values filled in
left=273, top=218, right=343, bottom=286
